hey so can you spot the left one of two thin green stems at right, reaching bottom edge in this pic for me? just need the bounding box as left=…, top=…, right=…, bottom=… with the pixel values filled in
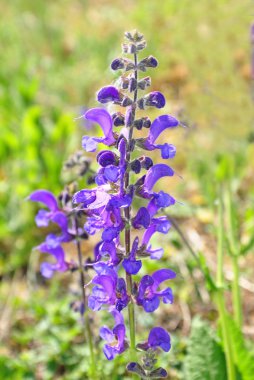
left=215, top=190, right=236, bottom=380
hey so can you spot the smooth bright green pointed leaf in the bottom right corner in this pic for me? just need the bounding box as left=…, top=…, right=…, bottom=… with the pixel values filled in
left=227, top=316, right=254, bottom=380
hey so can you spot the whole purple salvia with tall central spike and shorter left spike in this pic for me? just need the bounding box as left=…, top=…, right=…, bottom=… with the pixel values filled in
left=30, top=31, right=183, bottom=379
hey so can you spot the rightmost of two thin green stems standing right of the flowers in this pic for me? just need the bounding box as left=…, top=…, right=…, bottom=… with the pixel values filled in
left=226, top=184, right=243, bottom=329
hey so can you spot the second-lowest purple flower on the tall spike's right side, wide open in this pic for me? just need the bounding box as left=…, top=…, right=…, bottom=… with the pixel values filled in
left=137, top=269, right=176, bottom=313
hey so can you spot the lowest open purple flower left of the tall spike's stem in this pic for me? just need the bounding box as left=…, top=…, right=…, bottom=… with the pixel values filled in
left=100, top=310, right=127, bottom=360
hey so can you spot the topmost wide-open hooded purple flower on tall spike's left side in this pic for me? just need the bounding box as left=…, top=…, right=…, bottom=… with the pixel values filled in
left=82, top=108, right=115, bottom=152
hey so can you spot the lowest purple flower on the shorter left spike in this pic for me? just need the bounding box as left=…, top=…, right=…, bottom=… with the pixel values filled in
left=36, top=243, right=68, bottom=278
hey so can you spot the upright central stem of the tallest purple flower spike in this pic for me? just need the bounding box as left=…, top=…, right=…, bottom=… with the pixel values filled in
left=124, top=54, right=138, bottom=354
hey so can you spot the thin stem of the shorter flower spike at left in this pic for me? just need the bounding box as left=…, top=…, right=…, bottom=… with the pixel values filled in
left=74, top=216, right=96, bottom=379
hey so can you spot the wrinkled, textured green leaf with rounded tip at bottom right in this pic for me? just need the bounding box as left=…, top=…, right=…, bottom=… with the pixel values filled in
left=184, top=319, right=227, bottom=380
